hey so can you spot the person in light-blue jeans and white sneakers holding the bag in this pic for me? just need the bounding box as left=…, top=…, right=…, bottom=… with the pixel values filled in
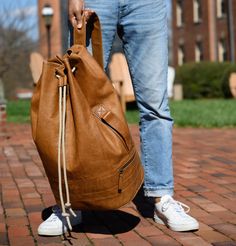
left=39, top=0, right=199, bottom=235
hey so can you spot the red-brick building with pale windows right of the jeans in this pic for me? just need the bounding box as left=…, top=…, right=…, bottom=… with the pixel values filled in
left=172, top=0, right=236, bottom=66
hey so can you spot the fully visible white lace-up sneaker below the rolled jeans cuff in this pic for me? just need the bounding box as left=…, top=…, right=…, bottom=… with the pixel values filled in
left=154, top=195, right=199, bottom=231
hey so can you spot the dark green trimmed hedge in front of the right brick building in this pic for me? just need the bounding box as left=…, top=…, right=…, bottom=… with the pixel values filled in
left=175, top=62, right=236, bottom=99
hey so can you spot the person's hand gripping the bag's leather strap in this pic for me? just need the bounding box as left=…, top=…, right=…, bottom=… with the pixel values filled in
left=68, top=0, right=94, bottom=29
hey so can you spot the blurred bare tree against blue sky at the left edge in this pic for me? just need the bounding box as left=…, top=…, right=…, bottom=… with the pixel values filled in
left=0, top=2, right=37, bottom=98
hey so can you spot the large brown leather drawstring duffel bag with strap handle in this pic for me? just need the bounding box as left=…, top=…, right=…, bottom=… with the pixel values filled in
left=31, top=14, right=143, bottom=225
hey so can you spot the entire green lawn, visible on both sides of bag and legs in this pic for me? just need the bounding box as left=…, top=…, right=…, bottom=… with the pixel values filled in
left=7, top=99, right=236, bottom=128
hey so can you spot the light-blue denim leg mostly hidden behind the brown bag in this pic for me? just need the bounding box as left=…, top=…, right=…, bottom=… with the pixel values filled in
left=85, top=0, right=118, bottom=70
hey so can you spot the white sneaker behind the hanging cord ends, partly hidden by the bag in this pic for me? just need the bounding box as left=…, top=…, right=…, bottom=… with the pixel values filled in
left=38, top=206, right=82, bottom=236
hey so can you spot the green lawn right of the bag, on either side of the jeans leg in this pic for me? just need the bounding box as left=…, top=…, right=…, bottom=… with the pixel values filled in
left=126, top=99, right=236, bottom=128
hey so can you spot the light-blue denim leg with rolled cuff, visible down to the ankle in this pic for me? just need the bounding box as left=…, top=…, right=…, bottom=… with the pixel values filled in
left=119, top=0, right=173, bottom=197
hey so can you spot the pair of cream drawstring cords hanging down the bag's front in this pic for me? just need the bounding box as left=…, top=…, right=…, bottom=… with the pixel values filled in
left=56, top=75, right=77, bottom=230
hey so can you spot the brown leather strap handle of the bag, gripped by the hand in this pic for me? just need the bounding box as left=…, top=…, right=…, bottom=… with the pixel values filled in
left=73, top=13, right=103, bottom=69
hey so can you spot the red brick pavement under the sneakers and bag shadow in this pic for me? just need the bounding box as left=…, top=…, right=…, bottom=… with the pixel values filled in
left=0, top=124, right=236, bottom=246
